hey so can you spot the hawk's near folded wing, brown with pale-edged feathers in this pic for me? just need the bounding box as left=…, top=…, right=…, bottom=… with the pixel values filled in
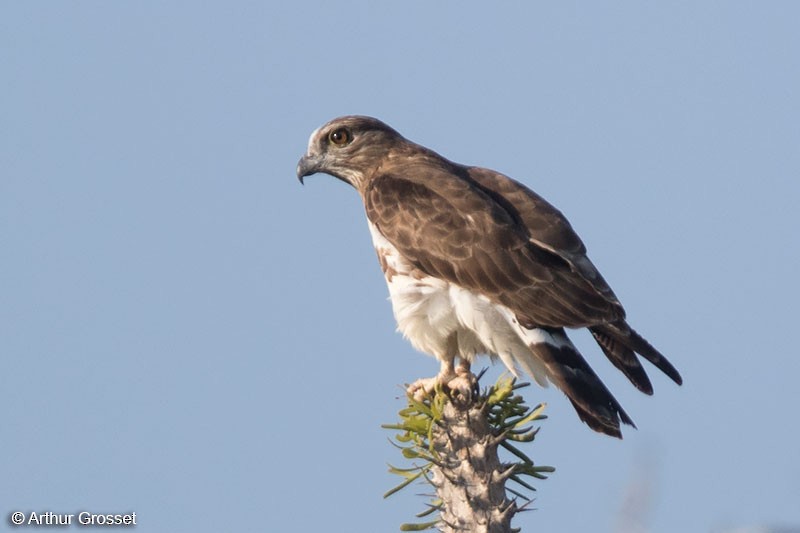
left=364, top=162, right=624, bottom=328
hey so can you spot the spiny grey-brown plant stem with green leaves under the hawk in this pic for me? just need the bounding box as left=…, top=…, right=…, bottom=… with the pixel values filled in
left=383, top=378, right=554, bottom=533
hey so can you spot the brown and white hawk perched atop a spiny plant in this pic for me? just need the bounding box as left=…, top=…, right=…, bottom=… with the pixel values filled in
left=297, top=116, right=682, bottom=438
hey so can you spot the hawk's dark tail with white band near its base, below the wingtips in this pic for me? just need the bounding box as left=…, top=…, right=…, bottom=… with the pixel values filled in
left=528, top=328, right=636, bottom=438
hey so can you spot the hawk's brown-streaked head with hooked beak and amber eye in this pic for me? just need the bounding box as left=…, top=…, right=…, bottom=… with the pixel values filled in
left=297, top=115, right=405, bottom=190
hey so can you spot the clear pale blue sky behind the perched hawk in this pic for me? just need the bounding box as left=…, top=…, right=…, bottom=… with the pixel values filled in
left=0, top=1, right=800, bottom=533
